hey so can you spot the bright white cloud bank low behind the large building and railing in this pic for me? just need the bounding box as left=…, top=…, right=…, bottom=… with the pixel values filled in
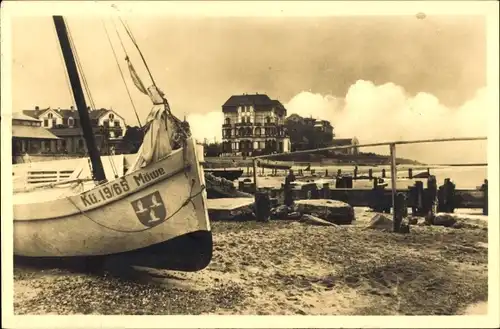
left=187, top=80, right=490, bottom=163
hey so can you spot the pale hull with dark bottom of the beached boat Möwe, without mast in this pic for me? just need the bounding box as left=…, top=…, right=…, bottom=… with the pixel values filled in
left=14, top=139, right=212, bottom=269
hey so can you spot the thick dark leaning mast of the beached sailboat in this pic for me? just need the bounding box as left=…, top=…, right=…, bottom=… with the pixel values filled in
left=53, top=16, right=106, bottom=182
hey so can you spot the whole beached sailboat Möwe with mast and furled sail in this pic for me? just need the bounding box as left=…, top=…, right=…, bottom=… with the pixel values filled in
left=13, top=16, right=212, bottom=271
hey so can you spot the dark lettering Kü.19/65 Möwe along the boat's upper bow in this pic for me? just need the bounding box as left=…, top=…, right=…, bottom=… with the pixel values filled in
left=80, top=168, right=166, bottom=207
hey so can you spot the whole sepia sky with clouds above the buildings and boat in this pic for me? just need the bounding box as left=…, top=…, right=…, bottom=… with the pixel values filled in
left=12, top=15, right=488, bottom=162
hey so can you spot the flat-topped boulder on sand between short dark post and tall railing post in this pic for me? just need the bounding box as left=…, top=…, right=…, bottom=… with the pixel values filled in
left=295, top=199, right=355, bottom=225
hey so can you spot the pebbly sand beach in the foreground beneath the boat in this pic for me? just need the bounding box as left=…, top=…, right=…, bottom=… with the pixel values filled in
left=14, top=208, right=488, bottom=315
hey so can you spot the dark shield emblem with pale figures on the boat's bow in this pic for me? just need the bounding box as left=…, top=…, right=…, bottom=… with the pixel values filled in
left=131, top=191, right=167, bottom=227
